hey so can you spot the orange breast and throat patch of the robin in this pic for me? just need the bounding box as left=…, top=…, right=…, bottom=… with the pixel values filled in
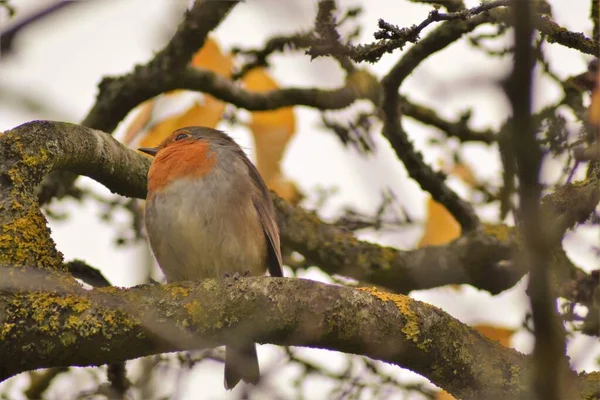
left=148, top=140, right=216, bottom=199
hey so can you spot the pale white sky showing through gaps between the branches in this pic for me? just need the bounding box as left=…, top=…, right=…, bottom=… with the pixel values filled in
left=0, top=0, right=599, bottom=399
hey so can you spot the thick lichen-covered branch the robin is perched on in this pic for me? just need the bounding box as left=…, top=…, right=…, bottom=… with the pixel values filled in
left=0, top=271, right=589, bottom=399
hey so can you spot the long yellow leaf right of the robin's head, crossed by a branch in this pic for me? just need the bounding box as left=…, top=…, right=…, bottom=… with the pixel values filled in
left=243, top=68, right=299, bottom=201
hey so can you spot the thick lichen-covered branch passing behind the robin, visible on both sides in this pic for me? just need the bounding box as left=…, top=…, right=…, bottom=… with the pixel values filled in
left=0, top=121, right=600, bottom=293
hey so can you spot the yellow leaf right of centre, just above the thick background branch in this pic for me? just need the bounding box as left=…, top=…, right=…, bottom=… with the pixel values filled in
left=418, top=197, right=461, bottom=247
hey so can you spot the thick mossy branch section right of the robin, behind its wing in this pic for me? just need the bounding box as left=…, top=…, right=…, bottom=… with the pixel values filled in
left=275, top=198, right=523, bottom=294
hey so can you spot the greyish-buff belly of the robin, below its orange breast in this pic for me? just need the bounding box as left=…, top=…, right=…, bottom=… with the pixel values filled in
left=146, top=178, right=266, bottom=282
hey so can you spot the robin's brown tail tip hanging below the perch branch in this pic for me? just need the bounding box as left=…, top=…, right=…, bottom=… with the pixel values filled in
left=225, top=343, right=260, bottom=390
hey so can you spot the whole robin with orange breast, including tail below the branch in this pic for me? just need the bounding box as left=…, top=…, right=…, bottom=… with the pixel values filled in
left=139, top=126, right=283, bottom=389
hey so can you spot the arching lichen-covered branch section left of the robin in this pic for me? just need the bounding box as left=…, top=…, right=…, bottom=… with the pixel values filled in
left=0, top=121, right=150, bottom=269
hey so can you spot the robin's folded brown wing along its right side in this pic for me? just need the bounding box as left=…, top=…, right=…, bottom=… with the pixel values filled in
left=242, top=154, right=283, bottom=276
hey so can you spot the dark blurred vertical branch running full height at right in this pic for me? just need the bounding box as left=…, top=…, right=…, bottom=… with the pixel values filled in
left=506, top=1, right=568, bottom=400
